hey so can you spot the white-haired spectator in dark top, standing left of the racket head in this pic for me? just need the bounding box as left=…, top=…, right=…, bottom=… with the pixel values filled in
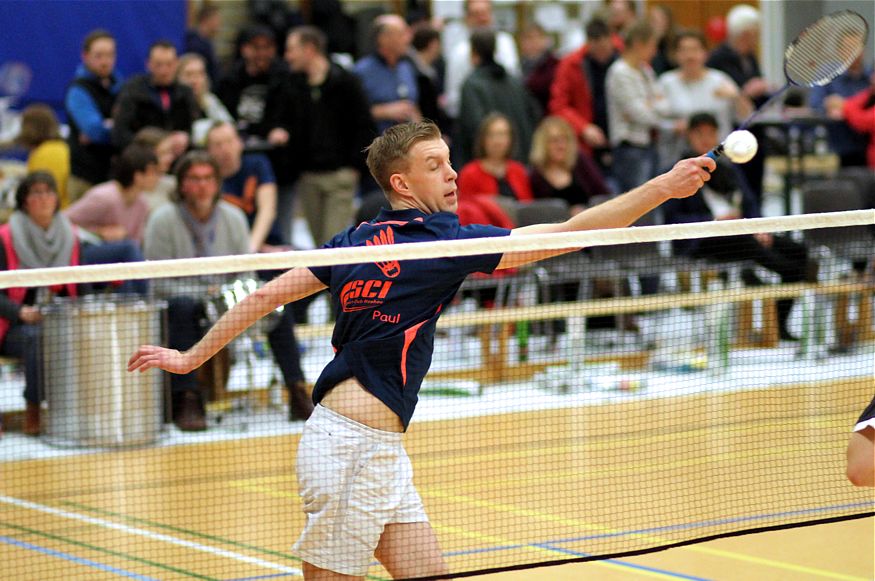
left=705, top=4, right=769, bottom=105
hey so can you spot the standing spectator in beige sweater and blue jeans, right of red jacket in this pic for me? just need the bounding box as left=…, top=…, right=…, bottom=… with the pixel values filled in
left=606, top=21, right=668, bottom=192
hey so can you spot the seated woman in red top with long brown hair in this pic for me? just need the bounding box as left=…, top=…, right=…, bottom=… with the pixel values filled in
left=457, top=113, right=532, bottom=224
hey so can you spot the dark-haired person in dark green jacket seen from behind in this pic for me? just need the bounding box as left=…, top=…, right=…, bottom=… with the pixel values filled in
left=458, top=28, right=541, bottom=162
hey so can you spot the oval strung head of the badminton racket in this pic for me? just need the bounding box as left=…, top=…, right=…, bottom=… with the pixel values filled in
left=784, top=10, right=869, bottom=86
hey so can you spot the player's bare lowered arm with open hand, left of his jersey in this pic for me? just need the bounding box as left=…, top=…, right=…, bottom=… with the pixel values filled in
left=128, top=268, right=325, bottom=373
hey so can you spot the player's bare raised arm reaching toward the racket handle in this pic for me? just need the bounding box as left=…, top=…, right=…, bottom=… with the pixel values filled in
left=498, top=157, right=716, bottom=268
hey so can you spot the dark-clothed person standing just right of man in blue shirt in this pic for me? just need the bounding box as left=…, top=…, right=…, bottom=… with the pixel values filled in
left=408, top=23, right=450, bottom=134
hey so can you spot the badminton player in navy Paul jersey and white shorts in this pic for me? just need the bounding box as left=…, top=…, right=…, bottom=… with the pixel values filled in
left=128, top=121, right=715, bottom=580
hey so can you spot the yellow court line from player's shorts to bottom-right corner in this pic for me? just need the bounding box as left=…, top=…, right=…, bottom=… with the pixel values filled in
left=420, top=488, right=867, bottom=581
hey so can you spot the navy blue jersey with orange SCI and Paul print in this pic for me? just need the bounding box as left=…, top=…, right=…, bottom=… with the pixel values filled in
left=310, top=210, right=510, bottom=428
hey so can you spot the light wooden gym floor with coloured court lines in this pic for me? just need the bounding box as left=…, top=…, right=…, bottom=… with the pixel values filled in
left=0, top=378, right=875, bottom=581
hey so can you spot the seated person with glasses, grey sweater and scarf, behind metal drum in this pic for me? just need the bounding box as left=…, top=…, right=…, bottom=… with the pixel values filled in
left=145, top=151, right=313, bottom=431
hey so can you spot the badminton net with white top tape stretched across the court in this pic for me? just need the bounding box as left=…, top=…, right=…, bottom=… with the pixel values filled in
left=0, top=210, right=875, bottom=580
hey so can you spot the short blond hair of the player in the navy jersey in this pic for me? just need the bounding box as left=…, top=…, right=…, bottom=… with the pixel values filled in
left=365, top=120, right=441, bottom=197
